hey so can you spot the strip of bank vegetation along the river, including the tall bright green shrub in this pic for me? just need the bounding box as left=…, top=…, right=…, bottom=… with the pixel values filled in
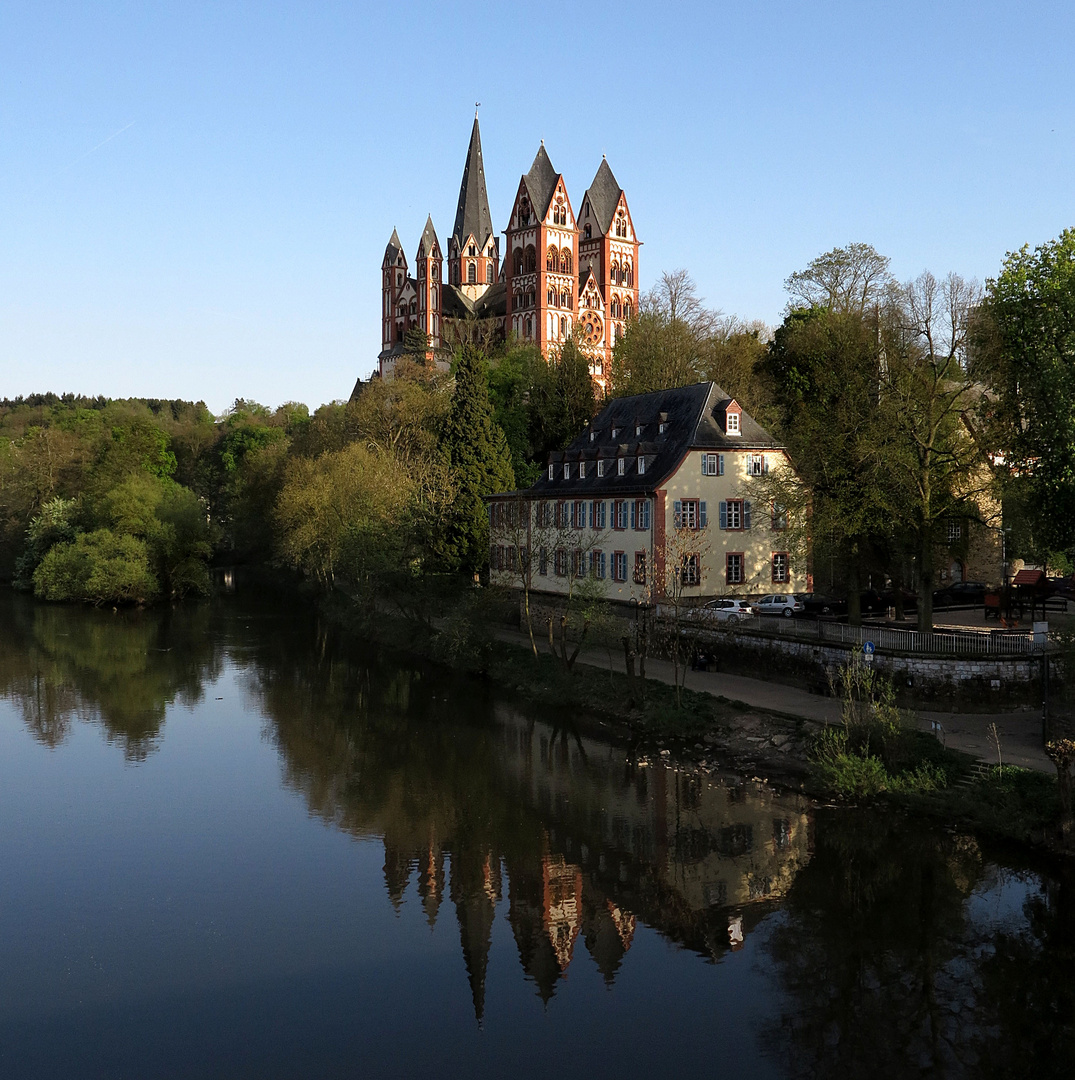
left=321, top=591, right=1071, bottom=852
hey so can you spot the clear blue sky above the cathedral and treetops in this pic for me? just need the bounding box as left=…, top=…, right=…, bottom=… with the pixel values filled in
left=0, top=0, right=1075, bottom=411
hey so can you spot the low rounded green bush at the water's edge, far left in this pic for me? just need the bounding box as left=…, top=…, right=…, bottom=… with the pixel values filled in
left=33, top=529, right=159, bottom=604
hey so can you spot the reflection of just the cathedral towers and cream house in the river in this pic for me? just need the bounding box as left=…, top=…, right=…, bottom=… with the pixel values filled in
left=369, top=711, right=810, bottom=1018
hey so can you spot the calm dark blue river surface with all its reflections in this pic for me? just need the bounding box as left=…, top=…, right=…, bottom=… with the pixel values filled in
left=0, top=593, right=1075, bottom=1078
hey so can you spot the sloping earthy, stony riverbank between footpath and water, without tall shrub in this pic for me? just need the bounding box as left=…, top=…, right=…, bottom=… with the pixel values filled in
left=323, top=593, right=1063, bottom=854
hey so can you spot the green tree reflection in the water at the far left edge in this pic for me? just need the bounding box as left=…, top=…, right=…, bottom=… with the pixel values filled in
left=0, top=595, right=220, bottom=760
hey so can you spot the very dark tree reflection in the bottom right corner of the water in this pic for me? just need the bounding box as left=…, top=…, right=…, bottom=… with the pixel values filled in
left=764, top=811, right=1075, bottom=1078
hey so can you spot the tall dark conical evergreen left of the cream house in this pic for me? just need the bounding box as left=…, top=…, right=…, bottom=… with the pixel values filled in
left=438, top=346, right=515, bottom=572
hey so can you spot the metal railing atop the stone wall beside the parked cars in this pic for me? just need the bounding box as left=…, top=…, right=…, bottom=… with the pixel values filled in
left=657, top=605, right=1044, bottom=657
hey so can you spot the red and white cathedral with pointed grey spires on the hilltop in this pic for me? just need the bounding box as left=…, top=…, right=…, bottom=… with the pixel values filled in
left=378, top=116, right=640, bottom=389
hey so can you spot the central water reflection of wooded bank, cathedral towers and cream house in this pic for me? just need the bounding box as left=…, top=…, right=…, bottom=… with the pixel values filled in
left=247, top=620, right=808, bottom=1018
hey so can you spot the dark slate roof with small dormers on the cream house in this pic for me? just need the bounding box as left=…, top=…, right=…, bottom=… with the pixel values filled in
left=494, top=382, right=781, bottom=498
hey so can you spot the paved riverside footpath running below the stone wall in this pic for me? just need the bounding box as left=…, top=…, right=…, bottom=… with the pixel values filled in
left=497, top=630, right=1056, bottom=773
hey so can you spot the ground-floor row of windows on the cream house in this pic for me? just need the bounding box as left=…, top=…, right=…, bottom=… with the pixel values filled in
left=489, top=544, right=791, bottom=586
